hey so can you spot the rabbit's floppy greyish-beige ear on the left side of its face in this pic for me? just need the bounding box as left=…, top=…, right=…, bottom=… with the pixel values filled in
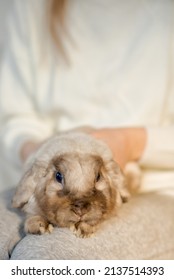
left=12, top=163, right=45, bottom=208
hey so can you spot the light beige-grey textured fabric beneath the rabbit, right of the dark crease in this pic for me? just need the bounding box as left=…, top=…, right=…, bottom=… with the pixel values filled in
left=1, top=193, right=174, bottom=260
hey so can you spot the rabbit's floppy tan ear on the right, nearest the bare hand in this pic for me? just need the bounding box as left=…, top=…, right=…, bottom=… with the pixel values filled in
left=102, top=160, right=130, bottom=205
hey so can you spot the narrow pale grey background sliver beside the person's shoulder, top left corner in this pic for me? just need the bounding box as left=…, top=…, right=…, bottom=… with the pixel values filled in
left=0, top=0, right=12, bottom=61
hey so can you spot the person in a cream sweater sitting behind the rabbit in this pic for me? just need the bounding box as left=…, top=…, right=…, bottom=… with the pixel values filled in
left=0, top=0, right=174, bottom=260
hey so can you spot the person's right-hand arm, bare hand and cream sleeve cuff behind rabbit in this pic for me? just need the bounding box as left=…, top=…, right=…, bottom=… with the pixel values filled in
left=91, top=125, right=174, bottom=169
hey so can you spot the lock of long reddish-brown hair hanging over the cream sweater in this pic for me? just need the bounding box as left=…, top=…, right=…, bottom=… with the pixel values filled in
left=47, top=0, right=68, bottom=59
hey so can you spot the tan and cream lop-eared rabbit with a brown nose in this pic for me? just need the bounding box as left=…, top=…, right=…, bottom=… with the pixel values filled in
left=12, top=131, right=136, bottom=238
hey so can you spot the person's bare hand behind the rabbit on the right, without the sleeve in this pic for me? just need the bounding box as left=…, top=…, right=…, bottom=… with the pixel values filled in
left=89, top=128, right=147, bottom=169
